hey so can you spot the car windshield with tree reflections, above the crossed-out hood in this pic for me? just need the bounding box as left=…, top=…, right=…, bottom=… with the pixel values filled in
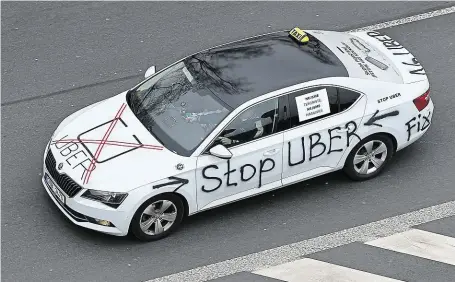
left=127, top=60, right=232, bottom=156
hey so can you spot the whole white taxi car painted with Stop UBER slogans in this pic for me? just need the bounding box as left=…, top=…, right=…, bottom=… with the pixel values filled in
left=42, top=28, right=434, bottom=240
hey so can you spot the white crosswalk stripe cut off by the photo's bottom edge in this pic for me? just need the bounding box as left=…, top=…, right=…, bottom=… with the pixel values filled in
left=253, top=258, right=401, bottom=282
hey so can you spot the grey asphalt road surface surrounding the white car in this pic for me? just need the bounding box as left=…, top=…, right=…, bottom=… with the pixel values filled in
left=1, top=1, right=455, bottom=281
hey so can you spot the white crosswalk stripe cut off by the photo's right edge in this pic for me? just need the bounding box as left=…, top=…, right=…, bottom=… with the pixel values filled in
left=365, top=229, right=455, bottom=265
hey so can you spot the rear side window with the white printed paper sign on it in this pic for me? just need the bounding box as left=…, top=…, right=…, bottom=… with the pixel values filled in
left=289, top=86, right=360, bottom=127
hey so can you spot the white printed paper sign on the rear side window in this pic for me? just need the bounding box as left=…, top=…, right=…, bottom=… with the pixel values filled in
left=295, top=89, right=330, bottom=122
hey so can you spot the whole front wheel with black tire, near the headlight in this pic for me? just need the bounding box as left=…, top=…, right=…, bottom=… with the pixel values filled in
left=130, top=194, right=185, bottom=241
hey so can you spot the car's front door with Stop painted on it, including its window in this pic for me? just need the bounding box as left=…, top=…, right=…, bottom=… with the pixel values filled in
left=196, top=98, right=283, bottom=210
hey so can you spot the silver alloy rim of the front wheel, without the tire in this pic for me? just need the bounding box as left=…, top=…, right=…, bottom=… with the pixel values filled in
left=139, top=200, right=177, bottom=235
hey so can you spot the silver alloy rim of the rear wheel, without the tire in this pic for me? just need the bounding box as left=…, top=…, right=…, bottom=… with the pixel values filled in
left=353, top=140, right=387, bottom=175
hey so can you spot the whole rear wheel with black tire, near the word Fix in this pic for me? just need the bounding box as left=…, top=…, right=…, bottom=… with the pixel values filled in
left=343, top=134, right=395, bottom=181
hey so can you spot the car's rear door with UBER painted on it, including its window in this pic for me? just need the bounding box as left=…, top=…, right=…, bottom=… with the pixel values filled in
left=282, top=86, right=366, bottom=185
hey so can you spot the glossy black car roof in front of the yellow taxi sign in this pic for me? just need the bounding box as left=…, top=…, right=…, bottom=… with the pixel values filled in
left=186, top=31, right=349, bottom=108
